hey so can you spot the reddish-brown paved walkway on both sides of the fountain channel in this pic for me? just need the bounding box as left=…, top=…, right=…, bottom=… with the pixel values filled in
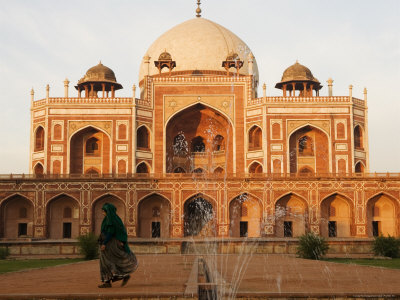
left=0, top=254, right=400, bottom=299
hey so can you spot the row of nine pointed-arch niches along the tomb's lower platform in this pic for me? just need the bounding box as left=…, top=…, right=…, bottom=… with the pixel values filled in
left=0, top=193, right=400, bottom=239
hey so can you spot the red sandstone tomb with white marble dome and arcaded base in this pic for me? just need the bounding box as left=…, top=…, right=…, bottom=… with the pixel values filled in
left=0, top=3, right=400, bottom=254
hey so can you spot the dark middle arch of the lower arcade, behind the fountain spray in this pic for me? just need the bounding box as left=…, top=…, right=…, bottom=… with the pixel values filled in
left=183, top=194, right=216, bottom=237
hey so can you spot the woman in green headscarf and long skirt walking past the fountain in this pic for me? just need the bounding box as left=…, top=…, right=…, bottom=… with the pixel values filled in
left=99, top=203, right=138, bottom=288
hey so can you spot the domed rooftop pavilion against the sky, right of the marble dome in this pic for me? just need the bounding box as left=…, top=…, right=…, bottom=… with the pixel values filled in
left=275, top=61, right=322, bottom=97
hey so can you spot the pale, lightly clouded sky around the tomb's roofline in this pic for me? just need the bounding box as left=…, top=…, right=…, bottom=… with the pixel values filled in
left=0, top=0, right=400, bottom=174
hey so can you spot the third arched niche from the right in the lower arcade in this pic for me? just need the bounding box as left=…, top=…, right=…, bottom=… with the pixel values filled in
left=275, top=194, right=308, bottom=237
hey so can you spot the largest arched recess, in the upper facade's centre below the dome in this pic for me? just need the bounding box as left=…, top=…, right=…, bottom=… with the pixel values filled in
left=165, top=103, right=233, bottom=173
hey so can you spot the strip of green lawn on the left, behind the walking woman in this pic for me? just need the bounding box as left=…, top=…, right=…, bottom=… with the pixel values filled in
left=0, top=258, right=83, bottom=274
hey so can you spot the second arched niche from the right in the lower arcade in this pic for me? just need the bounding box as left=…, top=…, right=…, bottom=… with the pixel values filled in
left=320, top=194, right=353, bottom=237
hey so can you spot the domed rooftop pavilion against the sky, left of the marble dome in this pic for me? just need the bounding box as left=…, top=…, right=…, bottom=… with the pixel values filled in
left=75, top=62, right=122, bottom=98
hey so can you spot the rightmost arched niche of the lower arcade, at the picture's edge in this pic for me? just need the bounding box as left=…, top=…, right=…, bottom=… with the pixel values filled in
left=367, top=193, right=400, bottom=237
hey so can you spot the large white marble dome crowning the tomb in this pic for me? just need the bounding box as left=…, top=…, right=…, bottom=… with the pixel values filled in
left=139, top=18, right=258, bottom=82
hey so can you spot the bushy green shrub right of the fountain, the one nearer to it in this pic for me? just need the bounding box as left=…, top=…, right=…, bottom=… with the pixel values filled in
left=297, top=232, right=329, bottom=259
